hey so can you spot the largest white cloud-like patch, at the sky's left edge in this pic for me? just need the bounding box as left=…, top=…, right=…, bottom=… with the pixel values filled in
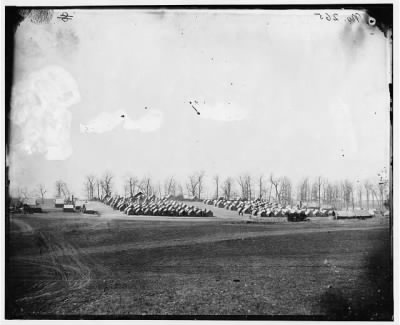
left=11, top=66, right=80, bottom=160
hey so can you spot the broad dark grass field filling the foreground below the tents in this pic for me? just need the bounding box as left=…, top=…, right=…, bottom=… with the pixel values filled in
left=6, top=202, right=393, bottom=320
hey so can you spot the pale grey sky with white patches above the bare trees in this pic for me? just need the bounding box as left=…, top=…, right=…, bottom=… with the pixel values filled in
left=7, top=10, right=390, bottom=196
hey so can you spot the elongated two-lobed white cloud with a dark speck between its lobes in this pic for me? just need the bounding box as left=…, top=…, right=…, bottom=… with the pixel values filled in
left=80, top=109, right=163, bottom=133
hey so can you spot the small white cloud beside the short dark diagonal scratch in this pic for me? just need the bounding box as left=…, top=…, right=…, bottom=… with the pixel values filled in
left=192, top=102, right=247, bottom=122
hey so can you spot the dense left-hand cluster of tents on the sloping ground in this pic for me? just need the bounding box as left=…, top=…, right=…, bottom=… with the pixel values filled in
left=102, top=193, right=214, bottom=217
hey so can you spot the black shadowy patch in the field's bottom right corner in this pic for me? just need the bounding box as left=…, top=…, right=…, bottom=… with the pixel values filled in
left=320, top=233, right=394, bottom=321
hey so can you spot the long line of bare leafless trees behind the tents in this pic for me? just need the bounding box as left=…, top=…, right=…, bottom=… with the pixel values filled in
left=10, top=169, right=389, bottom=209
